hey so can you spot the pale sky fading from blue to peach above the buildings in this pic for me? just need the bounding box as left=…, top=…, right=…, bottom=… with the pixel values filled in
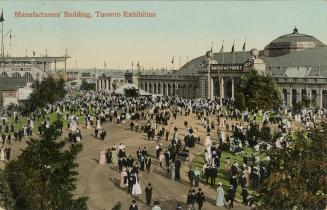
left=0, top=0, right=327, bottom=69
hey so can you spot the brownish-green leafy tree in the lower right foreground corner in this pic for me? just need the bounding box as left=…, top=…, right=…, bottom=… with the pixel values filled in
left=254, top=122, right=327, bottom=210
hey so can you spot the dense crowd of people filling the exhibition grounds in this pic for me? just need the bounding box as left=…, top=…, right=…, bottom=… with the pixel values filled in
left=0, top=89, right=327, bottom=209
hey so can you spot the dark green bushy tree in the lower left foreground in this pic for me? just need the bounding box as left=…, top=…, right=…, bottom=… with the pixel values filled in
left=4, top=125, right=87, bottom=210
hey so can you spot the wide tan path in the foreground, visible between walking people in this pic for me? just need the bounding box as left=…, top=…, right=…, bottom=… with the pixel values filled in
left=72, top=113, right=251, bottom=210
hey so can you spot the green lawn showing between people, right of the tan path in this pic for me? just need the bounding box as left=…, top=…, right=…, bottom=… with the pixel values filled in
left=192, top=147, right=265, bottom=201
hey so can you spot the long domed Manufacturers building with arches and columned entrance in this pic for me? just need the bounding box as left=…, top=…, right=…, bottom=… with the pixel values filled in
left=98, top=28, right=327, bottom=108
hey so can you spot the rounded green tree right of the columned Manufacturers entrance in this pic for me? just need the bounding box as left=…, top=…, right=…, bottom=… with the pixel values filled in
left=236, top=70, right=282, bottom=110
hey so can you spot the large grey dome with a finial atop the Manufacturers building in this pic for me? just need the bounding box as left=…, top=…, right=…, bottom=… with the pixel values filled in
left=264, top=27, right=326, bottom=57
